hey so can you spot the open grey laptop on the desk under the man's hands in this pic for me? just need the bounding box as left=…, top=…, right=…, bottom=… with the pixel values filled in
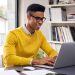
left=34, top=42, right=75, bottom=69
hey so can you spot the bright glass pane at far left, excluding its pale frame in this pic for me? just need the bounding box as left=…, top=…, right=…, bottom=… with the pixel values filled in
left=0, top=0, right=8, bottom=53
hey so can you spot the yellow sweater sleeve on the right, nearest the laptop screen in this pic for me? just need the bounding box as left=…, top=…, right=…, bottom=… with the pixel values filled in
left=41, top=31, right=58, bottom=57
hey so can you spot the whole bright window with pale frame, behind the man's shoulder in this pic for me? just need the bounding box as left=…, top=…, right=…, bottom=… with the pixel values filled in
left=0, top=0, right=16, bottom=55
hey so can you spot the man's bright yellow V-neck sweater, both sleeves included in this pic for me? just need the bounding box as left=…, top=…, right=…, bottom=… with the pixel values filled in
left=3, top=27, right=57, bottom=67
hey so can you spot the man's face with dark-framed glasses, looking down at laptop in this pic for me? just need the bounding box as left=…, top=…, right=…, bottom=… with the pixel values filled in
left=28, top=11, right=45, bottom=30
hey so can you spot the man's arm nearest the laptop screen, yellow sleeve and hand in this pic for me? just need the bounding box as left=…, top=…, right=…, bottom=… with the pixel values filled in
left=33, top=33, right=58, bottom=64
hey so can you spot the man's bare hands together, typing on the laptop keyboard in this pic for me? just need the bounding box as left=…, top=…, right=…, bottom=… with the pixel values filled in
left=32, top=57, right=56, bottom=65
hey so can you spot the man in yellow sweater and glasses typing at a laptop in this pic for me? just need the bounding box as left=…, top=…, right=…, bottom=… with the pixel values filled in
left=3, top=4, right=57, bottom=67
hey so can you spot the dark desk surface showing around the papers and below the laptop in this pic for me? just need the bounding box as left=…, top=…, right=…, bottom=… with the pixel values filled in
left=3, top=66, right=75, bottom=75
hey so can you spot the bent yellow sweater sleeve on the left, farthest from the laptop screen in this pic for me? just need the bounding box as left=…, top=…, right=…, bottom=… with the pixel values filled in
left=3, top=32, right=32, bottom=67
